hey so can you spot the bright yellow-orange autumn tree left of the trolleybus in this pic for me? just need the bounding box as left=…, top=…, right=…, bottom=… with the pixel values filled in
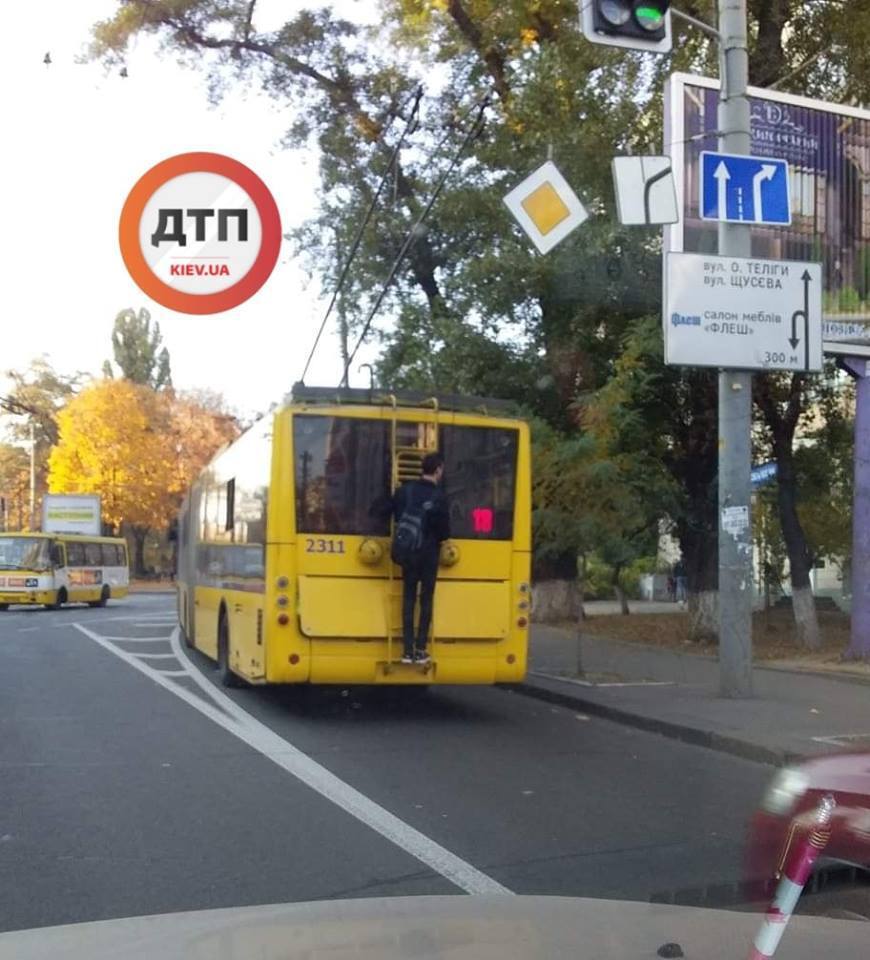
left=48, top=380, right=237, bottom=572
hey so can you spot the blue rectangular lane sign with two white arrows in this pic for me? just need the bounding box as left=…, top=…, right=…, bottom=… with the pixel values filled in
left=700, top=151, right=791, bottom=227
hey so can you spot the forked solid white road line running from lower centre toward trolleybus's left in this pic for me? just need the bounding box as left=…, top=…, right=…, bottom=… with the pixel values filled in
left=74, top=623, right=513, bottom=895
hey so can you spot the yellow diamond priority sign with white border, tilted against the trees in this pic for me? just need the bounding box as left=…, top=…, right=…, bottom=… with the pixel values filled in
left=504, top=160, right=589, bottom=253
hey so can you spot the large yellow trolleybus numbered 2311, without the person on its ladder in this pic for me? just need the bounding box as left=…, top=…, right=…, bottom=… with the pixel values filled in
left=177, top=385, right=531, bottom=686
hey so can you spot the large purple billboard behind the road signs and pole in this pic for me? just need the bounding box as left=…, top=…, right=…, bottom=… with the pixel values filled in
left=665, top=73, right=870, bottom=353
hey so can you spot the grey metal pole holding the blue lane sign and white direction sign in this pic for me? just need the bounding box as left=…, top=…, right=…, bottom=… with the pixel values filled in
left=719, top=0, right=752, bottom=697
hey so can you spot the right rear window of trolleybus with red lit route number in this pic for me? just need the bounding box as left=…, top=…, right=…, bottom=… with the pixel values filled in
left=441, top=426, right=518, bottom=540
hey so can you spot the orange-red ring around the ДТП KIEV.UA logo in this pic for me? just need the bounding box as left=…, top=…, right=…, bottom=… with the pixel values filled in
left=118, top=153, right=281, bottom=314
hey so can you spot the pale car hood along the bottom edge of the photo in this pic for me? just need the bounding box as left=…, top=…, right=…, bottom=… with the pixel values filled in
left=0, top=896, right=867, bottom=960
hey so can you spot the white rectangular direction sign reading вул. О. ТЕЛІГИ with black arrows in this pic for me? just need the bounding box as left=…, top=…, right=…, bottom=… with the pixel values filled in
left=664, top=253, right=822, bottom=371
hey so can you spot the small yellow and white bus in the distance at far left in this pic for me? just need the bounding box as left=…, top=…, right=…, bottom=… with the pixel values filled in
left=0, top=533, right=130, bottom=610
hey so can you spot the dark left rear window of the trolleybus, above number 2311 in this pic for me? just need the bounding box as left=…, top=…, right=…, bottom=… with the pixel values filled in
left=293, top=416, right=390, bottom=536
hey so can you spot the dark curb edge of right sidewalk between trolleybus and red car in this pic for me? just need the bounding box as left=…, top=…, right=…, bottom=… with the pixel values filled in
left=510, top=680, right=806, bottom=766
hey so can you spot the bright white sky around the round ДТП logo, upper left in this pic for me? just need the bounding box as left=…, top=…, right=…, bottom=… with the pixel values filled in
left=0, top=0, right=377, bottom=416
